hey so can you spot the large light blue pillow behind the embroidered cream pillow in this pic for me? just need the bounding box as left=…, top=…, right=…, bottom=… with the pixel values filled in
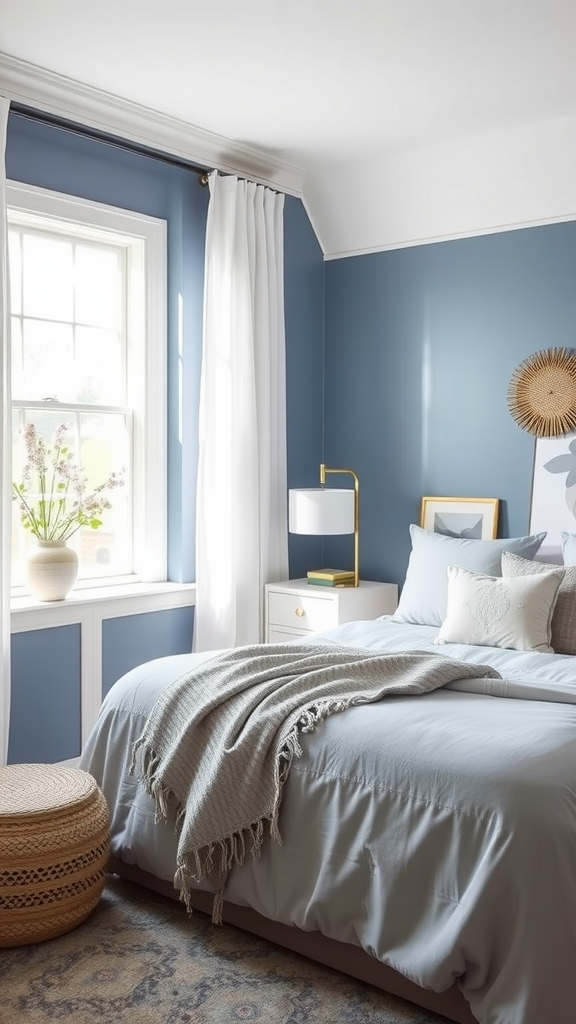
left=393, top=524, right=546, bottom=626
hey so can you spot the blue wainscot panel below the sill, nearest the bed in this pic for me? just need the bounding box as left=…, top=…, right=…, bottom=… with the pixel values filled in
left=102, top=607, right=194, bottom=697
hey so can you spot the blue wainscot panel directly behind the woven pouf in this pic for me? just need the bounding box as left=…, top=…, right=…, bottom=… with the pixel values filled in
left=8, top=624, right=81, bottom=764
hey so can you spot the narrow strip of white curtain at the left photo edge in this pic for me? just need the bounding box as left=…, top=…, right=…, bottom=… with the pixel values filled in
left=0, top=96, right=12, bottom=764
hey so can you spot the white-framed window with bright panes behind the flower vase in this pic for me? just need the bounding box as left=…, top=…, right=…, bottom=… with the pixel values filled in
left=7, top=184, right=166, bottom=592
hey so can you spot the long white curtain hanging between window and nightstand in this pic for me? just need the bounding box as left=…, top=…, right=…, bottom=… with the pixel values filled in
left=195, top=172, right=288, bottom=650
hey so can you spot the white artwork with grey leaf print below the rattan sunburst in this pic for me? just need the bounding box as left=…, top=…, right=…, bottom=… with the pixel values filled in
left=530, top=432, right=576, bottom=562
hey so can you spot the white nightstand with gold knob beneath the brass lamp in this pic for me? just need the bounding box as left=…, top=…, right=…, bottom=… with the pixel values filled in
left=264, top=579, right=398, bottom=643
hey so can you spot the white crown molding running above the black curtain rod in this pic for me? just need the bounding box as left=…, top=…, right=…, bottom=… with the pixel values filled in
left=0, top=53, right=305, bottom=197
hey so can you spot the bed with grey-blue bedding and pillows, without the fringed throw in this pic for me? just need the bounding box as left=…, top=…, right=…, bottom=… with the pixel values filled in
left=80, top=527, right=576, bottom=1024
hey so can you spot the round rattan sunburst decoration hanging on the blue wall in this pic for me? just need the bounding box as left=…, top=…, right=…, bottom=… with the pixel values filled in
left=508, top=348, right=576, bottom=437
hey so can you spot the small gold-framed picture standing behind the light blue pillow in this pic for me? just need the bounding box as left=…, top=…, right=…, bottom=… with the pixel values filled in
left=420, top=498, right=499, bottom=541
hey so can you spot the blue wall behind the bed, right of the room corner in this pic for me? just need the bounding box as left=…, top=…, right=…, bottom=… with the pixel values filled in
left=325, top=223, right=576, bottom=583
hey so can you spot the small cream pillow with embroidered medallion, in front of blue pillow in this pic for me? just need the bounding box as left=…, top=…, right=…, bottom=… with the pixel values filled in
left=435, top=565, right=564, bottom=654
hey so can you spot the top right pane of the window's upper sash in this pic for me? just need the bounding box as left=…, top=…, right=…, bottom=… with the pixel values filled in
left=76, top=245, right=122, bottom=330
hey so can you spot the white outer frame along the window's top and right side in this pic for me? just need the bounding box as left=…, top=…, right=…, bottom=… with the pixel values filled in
left=6, top=181, right=168, bottom=595
